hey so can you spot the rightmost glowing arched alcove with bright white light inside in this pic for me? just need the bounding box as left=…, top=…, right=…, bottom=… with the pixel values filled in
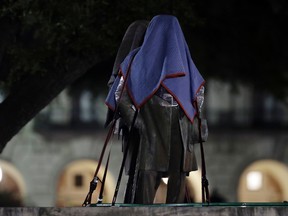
left=238, top=160, right=288, bottom=202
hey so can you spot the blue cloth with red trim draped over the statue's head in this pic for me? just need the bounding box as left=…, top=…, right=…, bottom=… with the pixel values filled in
left=106, top=15, right=204, bottom=121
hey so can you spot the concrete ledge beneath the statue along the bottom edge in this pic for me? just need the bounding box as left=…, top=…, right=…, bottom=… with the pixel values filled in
left=0, top=203, right=288, bottom=216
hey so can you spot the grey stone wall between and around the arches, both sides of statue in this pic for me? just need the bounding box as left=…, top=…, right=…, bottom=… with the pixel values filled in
left=0, top=123, right=288, bottom=207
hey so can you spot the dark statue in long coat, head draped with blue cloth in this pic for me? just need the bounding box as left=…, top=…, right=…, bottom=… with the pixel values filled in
left=106, top=15, right=207, bottom=204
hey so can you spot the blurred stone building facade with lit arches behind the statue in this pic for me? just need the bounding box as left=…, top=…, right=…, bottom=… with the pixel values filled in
left=0, top=80, right=288, bottom=206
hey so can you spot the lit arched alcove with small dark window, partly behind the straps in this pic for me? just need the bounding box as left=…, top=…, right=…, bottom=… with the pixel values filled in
left=56, top=160, right=115, bottom=207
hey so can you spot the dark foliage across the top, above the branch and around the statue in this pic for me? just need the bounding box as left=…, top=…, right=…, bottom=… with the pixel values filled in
left=0, top=0, right=288, bottom=97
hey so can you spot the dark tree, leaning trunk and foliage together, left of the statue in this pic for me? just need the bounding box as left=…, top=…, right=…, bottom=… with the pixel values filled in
left=0, top=0, right=200, bottom=152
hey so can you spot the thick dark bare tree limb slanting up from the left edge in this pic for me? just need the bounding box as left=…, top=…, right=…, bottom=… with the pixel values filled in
left=0, top=59, right=96, bottom=153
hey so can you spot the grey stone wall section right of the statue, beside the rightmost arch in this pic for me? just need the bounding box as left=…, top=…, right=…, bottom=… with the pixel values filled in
left=198, top=130, right=288, bottom=202
